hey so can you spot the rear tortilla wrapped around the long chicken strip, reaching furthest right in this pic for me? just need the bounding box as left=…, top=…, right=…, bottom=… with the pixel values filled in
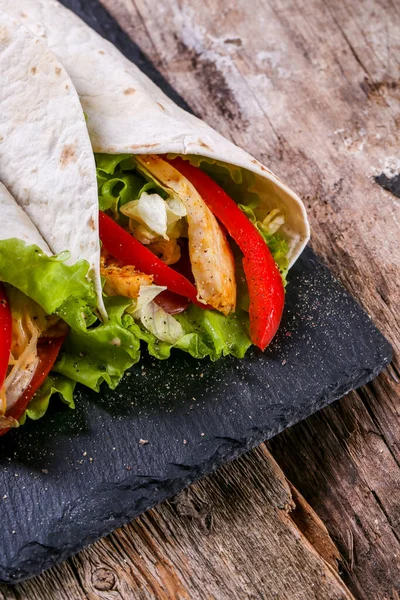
left=0, top=0, right=309, bottom=266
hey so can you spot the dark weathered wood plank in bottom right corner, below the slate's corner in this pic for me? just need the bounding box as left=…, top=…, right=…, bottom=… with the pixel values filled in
left=271, top=378, right=400, bottom=599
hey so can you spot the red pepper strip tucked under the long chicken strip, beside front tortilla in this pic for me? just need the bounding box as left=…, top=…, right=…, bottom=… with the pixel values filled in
left=99, top=211, right=202, bottom=308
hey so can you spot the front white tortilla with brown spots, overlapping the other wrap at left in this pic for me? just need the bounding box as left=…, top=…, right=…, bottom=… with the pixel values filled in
left=0, top=9, right=105, bottom=314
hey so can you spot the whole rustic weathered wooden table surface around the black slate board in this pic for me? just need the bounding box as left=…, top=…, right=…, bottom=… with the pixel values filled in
left=0, top=0, right=400, bottom=600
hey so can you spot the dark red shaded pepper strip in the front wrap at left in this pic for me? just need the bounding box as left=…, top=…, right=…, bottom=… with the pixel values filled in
left=0, top=334, right=67, bottom=436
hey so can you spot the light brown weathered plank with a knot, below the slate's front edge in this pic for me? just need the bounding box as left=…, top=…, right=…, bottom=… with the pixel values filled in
left=0, top=447, right=352, bottom=600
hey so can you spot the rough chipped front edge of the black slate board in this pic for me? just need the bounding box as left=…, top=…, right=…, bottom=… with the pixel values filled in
left=0, top=350, right=392, bottom=584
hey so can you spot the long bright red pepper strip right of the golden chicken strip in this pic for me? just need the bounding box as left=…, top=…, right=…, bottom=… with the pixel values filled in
left=168, top=157, right=285, bottom=350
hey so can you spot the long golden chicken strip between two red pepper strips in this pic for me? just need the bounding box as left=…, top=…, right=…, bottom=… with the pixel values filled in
left=135, top=155, right=236, bottom=315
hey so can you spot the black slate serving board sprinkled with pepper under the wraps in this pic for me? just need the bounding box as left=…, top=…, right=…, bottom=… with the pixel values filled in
left=0, top=0, right=391, bottom=582
